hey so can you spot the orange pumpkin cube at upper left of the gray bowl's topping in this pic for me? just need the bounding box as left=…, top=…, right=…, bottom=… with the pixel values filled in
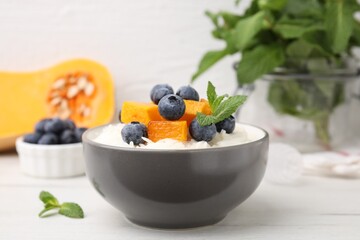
left=121, top=102, right=165, bottom=125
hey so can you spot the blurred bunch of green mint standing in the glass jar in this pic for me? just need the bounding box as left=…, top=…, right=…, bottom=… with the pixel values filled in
left=192, top=0, right=360, bottom=145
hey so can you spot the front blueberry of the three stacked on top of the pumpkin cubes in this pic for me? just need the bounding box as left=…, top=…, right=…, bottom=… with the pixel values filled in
left=158, top=94, right=185, bottom=120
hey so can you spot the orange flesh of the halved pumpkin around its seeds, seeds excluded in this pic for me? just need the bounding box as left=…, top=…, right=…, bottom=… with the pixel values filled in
left=0, top=59, right=115, bottom=149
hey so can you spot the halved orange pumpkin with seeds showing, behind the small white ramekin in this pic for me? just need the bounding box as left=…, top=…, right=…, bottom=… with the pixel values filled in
left=0, top=59, right=115, bottom=148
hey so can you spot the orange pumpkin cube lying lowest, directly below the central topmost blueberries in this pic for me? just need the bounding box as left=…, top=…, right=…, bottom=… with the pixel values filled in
left=148, top=121, right=188, bottom=142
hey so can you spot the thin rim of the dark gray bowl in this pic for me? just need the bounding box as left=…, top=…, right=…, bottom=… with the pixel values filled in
left=82, top=123, right=269, bottom=153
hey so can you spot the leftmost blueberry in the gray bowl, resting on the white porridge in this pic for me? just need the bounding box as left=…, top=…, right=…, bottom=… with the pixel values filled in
left=121, top=122, right=148, bottom=145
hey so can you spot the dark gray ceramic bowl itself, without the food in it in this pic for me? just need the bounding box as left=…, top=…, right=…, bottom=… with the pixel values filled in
left=83, top=126, right=269, bottom=228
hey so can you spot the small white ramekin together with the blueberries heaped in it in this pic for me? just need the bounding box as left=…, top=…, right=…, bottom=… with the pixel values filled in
left=16, top=118, right=87, bottom=178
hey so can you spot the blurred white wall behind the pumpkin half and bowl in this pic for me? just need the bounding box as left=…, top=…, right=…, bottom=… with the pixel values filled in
left=0, top=0, right=248, bottom=114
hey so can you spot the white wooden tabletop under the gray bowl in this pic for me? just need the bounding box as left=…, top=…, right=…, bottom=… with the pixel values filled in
left=0, top=153, right=360, bottom=240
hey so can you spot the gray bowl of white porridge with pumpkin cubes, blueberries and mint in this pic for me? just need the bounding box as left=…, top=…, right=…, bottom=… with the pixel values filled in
left=83, top=82, right=269, bottom=229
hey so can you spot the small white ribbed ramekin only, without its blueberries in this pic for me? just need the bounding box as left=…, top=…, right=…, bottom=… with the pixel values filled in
left=16, top=137, right=85, bottom=178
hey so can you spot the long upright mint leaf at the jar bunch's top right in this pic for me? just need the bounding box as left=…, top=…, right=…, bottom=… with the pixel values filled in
left=325, top=0, right=353, bottom=53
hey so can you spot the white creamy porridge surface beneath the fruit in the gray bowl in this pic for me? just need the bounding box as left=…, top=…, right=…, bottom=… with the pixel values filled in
left=94, top=123, right=265, bottom=149
